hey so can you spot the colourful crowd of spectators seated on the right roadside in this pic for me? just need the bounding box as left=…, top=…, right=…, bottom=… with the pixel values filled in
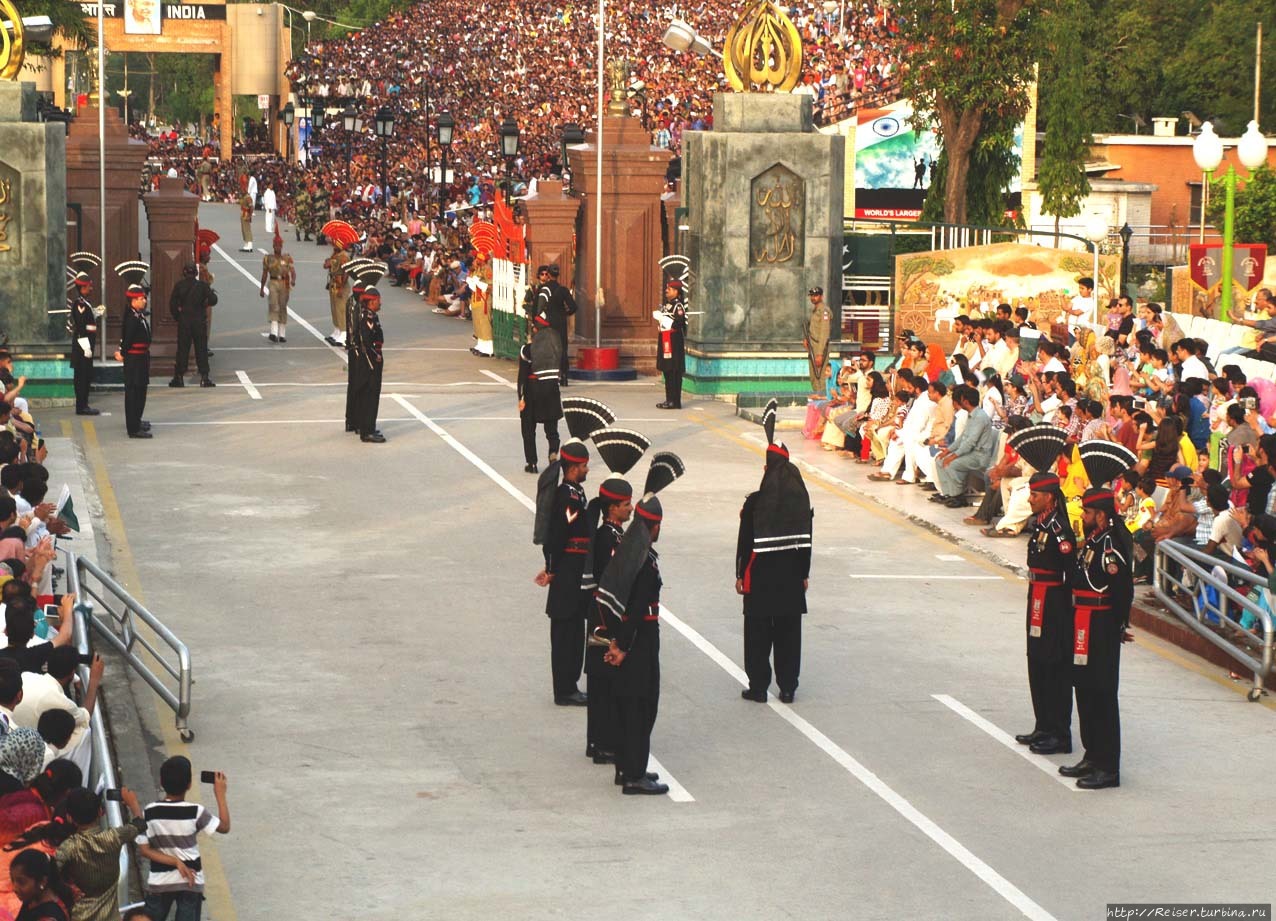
left=808, top=290, right=1276, bottom=637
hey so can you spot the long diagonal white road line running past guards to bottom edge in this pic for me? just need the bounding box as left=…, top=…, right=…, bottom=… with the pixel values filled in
left=390, top=394, right=1071, bottom=903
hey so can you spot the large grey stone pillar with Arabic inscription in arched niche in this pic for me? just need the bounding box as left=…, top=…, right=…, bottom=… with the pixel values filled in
left=683, top=93, right=846, bottom=394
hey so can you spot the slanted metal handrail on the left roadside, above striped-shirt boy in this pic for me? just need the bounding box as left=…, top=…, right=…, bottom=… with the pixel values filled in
left=68, top=556, right=195, bottom=742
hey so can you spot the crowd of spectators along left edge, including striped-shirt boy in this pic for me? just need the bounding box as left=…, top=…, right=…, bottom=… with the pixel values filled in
left=0, top=350, right=230, bottom=921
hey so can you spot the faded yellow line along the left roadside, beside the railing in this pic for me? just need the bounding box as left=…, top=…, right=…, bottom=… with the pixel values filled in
left=79, top=420, right=239, bottom=921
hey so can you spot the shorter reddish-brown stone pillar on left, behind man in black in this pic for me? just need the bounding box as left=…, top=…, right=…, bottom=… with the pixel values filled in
left=142, top=176, right=200, bottom=378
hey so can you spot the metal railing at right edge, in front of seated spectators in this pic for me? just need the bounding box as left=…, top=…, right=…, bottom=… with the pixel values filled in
left=1152, top=541, right=1273, bottom=700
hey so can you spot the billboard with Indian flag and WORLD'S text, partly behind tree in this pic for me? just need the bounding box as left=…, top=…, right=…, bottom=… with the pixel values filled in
left=855, top=99, right=1023, bottom=221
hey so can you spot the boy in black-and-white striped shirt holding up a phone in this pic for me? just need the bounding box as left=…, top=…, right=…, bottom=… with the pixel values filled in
left=138, top=755, right=231, bottom=921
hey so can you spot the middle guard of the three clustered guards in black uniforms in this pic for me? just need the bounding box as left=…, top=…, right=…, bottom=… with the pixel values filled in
left=584, top=477, right=634, bottom=764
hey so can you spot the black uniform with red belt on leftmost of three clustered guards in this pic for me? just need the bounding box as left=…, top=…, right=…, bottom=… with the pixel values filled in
left=542, top=481, right=593, bottom=699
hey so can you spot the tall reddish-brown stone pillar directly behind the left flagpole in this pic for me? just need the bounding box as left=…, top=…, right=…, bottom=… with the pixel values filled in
left=66, top=106, right=147, bottom=346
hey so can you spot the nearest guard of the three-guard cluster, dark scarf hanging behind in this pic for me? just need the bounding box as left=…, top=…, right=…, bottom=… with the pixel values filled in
left=598, top=496, right=669, bottom=796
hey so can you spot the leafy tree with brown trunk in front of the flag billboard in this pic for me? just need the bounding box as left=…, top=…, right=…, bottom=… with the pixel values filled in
left=894, top=0, right=1042, bottom=223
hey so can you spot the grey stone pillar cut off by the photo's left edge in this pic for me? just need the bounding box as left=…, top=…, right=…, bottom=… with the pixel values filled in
left=0, top=80, right=66, bottom=346
